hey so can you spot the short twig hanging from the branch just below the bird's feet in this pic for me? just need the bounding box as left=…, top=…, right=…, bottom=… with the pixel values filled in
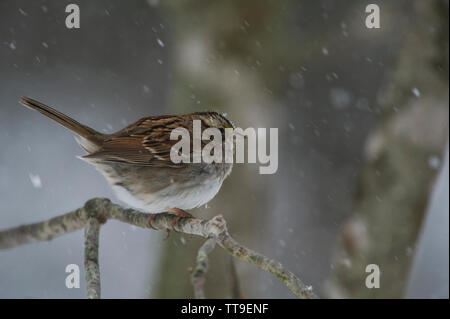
left=191, top=237, right=216, bottom=299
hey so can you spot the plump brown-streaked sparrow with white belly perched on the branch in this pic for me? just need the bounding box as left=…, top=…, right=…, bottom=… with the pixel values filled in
left=19, top=96, right=234, bottom=228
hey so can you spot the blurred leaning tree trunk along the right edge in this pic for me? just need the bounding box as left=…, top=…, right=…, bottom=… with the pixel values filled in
left=327, top=0, right=449, bottom=298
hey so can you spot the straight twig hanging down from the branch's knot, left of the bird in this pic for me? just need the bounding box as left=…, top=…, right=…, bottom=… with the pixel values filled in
left=84, top=217, right=100, bottom=299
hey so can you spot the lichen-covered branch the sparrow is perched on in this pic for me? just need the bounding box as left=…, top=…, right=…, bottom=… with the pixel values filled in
left=0, top=198, right=317, bottom=298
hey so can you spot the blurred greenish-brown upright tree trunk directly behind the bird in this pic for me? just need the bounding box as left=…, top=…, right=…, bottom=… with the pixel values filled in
left=153, top=0, right=302, bottom=298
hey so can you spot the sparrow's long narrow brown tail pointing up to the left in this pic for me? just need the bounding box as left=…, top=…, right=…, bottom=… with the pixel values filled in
left=19, top=96, right=105, bottom=152
